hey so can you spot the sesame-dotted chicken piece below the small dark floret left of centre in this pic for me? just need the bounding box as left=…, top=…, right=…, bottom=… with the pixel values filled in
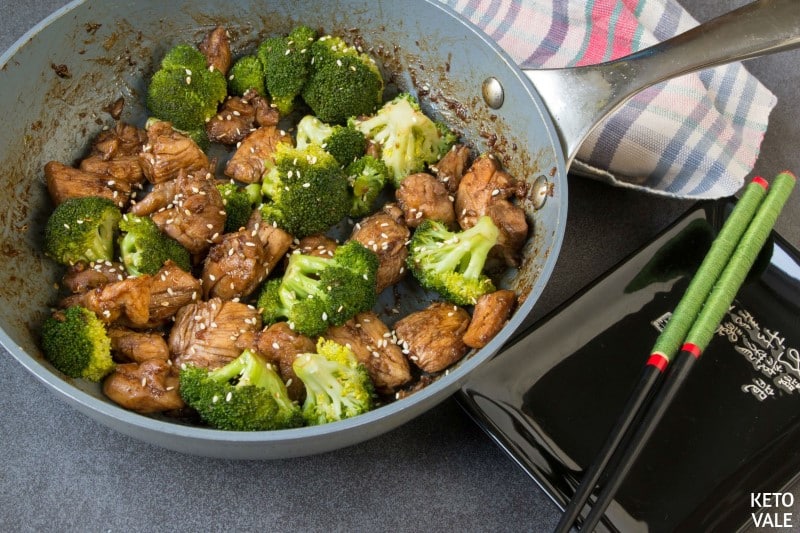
left=203, top=228, right=274, bottom=300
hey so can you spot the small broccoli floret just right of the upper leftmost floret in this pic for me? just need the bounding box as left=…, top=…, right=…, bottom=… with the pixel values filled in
left=119, top=213, right=192, bottom=276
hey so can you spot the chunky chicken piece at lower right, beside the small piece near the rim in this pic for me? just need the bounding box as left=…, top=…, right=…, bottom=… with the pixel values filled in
left=395, top=302, right=469, bottom=372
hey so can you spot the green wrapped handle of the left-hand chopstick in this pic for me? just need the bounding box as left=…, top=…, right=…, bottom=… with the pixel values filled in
left=651, top=177, right=769, bottom=366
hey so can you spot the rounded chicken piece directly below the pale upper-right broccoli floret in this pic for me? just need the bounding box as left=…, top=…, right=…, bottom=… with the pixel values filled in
left=395, top=172, right=456, bottom=228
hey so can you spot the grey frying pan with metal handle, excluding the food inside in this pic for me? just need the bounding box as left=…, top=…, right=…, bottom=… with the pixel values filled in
left=0, top=0, right=800, bottom=459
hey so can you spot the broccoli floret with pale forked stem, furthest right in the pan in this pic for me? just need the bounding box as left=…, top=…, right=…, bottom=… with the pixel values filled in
left=407, top=215, right=500, bottom=305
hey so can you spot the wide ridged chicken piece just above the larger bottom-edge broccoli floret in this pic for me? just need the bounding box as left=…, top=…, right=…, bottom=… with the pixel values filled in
left=167, top=298, right=261, bottom=370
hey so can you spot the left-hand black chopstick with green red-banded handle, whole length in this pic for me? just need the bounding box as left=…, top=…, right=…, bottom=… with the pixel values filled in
left=556, top=176, right=769, bottom=533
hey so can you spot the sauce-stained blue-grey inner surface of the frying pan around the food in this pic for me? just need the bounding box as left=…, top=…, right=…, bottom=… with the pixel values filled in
left=0, top=0, right=567, bottom=457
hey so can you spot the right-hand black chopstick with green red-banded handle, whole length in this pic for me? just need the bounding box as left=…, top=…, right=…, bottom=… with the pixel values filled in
left=581, top=171, right=797, bottom=531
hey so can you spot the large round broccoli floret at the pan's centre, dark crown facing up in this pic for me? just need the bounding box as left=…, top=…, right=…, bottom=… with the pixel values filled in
left=260, top=143, right=350, bottom=238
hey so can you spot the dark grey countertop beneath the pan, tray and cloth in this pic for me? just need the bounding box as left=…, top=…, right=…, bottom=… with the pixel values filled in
left=0, top=0, right=800, bottom=531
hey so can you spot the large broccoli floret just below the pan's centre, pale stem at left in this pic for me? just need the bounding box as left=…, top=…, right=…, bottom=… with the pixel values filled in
left=257, top=241, right=378, bottom=336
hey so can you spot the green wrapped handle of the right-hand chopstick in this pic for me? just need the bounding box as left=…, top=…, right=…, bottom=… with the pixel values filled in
left=686, top=172, right=797, bottom=351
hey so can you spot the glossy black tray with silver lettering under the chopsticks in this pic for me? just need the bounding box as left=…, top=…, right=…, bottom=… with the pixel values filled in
left=459, top=201, right=800, bottom=533
